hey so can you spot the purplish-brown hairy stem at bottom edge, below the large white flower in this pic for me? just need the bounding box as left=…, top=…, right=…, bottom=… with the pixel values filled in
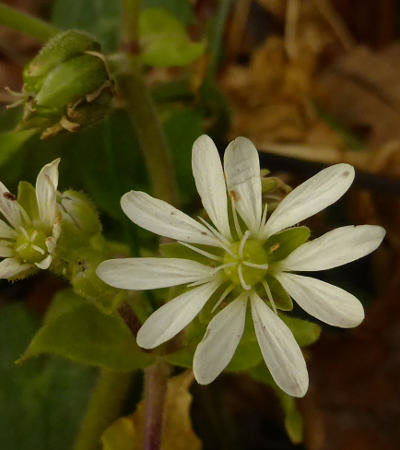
left=143, top=361, right=169, bottom=450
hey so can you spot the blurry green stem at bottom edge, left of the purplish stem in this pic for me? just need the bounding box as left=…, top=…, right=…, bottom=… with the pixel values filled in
left=74, top=370, right=132, bottom=450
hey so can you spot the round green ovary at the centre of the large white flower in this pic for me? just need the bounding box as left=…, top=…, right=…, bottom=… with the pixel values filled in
left=223, top=239, right=268, bottom=286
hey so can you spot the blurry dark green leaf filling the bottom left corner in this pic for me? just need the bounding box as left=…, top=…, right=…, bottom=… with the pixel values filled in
left=0, top=304, right=96, bottom=450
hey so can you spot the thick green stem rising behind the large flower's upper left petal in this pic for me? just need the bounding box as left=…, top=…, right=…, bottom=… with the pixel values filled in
left=118, top=59, right=176, bottom=204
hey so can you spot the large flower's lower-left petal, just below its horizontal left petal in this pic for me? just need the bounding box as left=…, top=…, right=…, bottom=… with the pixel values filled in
left=136, top=281, right=220, bottom=348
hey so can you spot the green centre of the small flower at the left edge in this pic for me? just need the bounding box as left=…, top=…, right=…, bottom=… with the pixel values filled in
left=15, top=228, right=48, bottom=263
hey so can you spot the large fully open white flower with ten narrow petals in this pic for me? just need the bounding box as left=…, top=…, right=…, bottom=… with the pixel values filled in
left=97, top=136, right=385, bottom=397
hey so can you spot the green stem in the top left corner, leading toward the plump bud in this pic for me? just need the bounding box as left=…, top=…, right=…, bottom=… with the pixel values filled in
left=0, top=3, right=59, bottom=41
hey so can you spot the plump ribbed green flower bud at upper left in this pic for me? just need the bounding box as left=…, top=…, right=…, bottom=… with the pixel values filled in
left=18, top=30, right=114, bottom=139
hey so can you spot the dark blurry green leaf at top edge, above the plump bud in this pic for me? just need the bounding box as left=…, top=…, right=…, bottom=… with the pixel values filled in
left=52, top=0, right=122, bottom=52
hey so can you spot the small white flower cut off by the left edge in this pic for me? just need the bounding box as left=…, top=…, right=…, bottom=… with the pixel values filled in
left=0, top=159, right=60, bottom=279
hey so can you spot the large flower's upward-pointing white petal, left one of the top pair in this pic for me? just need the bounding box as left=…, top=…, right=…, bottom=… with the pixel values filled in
left=192, top=135, right=231, bottom=239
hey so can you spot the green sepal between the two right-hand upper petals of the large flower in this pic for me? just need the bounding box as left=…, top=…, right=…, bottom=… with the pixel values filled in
left=264, top=226, right=311, bottom=263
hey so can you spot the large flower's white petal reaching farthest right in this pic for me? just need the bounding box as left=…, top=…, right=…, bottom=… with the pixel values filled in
left=281, top=225, right=386, bottom=271
